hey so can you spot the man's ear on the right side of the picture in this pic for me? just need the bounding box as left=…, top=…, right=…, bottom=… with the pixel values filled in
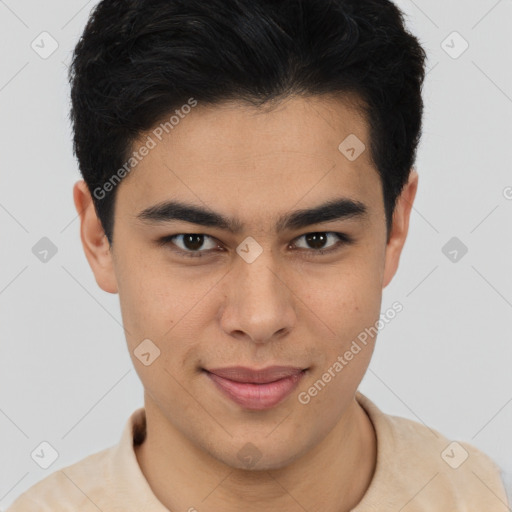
left=382, top=168, right=418, bottom=288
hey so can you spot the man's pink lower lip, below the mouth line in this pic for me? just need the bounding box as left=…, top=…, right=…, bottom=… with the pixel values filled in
left=205, top=370, right=305, bottom=411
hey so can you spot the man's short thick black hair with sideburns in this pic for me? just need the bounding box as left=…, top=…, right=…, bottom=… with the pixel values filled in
left=69, top=0, right=426, bottom=245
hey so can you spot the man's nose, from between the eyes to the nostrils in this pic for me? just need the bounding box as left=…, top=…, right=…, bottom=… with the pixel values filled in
left=221, top=249, right=297, bottom=344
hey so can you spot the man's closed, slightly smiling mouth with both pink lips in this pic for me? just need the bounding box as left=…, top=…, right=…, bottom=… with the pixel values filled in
left=203, top=366, right=307, bottom=410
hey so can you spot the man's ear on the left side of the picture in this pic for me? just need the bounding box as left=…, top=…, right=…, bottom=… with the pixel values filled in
left=73, top=180, right=118, bottom=293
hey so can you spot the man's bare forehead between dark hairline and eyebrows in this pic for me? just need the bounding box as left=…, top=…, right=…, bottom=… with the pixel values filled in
left=116, top=97, right=380, bottom=226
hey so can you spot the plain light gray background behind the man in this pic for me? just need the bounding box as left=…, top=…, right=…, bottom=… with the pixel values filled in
left=0, top=0, right=512, bottom=508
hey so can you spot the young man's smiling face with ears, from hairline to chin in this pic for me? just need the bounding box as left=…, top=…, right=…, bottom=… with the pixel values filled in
left=75, top=97, right=417, bottom=468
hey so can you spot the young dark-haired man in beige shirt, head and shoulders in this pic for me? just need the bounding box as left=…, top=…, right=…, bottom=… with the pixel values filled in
left=10, top=0, right=508, bottom=512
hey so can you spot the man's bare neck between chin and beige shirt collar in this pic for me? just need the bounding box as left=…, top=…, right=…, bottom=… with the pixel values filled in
left=135, top=399, right=377, bottom=512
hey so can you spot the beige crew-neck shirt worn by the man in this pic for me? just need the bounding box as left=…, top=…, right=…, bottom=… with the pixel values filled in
left=7, top=392, right=508, bottom=512
